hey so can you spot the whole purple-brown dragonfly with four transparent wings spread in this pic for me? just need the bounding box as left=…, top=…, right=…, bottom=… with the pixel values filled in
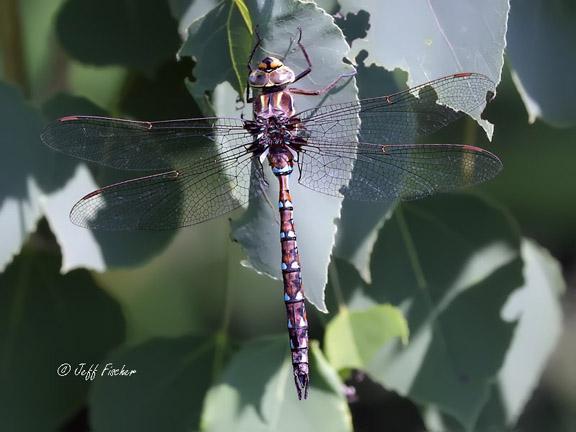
left=42, top=30, right=502, bottom=399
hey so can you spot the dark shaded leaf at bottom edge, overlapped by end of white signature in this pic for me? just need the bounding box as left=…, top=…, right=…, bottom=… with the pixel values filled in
left=89, top=336, right=215, bottom=432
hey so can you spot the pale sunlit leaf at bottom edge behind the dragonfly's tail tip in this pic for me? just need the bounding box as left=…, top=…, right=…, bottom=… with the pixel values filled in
left=202, top=336, right=352, bottom=432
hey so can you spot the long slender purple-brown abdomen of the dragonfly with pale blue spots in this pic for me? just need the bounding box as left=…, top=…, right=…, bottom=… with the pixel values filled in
left=272, top=168, right=310, bottom=399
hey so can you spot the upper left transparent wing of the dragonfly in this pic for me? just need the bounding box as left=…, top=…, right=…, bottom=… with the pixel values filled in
left=41, top=116, right=254, bottom=170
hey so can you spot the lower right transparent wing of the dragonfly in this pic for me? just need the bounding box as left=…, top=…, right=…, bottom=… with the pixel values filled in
left=299, top=143, right=502, bottom=201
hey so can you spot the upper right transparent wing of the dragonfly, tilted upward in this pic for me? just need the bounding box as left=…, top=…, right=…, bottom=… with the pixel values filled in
left=296, top=73, right=496, bottom=144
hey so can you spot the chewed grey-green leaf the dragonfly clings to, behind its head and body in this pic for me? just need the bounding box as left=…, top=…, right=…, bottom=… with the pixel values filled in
left=180, top=0, right=356, bottom=310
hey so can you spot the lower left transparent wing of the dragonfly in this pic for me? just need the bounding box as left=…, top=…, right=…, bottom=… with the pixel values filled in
left=70, top=153, right=264, bottom=231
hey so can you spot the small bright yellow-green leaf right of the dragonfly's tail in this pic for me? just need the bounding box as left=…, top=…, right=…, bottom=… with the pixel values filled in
left=325, top=305, right=409, bottom=370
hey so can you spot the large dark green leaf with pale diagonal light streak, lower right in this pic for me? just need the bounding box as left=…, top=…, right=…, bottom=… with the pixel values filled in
left=350, top=195, right=523, bottom=428
